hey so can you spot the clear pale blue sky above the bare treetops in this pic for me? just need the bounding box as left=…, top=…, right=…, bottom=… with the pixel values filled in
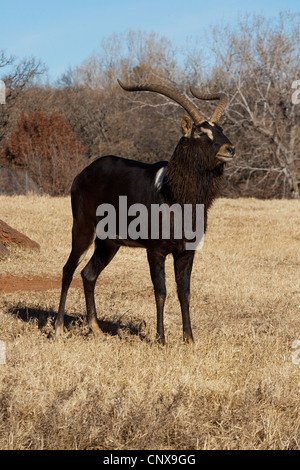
left=0, top=0, right=300, bottom=81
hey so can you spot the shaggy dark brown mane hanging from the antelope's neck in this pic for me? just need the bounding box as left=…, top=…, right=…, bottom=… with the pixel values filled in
left=164, top=137, right=224, bottom=210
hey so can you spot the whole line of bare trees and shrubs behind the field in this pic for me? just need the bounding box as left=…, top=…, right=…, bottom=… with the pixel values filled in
left=0, top=12, right=300, bottom=198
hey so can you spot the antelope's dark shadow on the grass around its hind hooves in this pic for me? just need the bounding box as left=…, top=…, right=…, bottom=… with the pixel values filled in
left=7, top=305, right=146, bottom=340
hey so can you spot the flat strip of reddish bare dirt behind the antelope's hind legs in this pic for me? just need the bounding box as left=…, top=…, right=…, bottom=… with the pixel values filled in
left=0, top=276, right=82, bottom=294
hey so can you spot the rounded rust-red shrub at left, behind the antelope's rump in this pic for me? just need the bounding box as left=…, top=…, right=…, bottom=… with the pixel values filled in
left=2, top=110, right=84, bottom=195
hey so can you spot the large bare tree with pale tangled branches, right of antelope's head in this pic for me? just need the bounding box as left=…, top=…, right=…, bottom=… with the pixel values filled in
left=211, top=12, right=300, bottom=198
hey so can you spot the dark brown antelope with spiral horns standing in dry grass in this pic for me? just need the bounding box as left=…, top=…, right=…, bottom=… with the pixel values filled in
left=55, top=81, right=235, bottom=344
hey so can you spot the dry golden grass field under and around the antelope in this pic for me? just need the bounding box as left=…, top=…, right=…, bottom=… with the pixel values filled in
left=0, top=196, right=300, bottom=450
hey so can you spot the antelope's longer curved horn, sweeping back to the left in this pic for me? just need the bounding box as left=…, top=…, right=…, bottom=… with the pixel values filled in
left=118, top=80, right=206, bottom=124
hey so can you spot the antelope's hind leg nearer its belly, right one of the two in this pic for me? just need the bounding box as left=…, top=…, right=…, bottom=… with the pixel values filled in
left=81, top=238, right=119, bottom=337
